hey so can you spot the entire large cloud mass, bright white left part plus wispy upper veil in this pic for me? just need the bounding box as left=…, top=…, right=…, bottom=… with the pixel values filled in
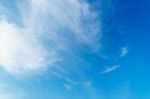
left=0, top=0, right=101, bottom=74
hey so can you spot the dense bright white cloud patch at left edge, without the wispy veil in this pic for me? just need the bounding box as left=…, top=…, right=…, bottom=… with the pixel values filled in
left=0, top=21, right=59, bottom=73
